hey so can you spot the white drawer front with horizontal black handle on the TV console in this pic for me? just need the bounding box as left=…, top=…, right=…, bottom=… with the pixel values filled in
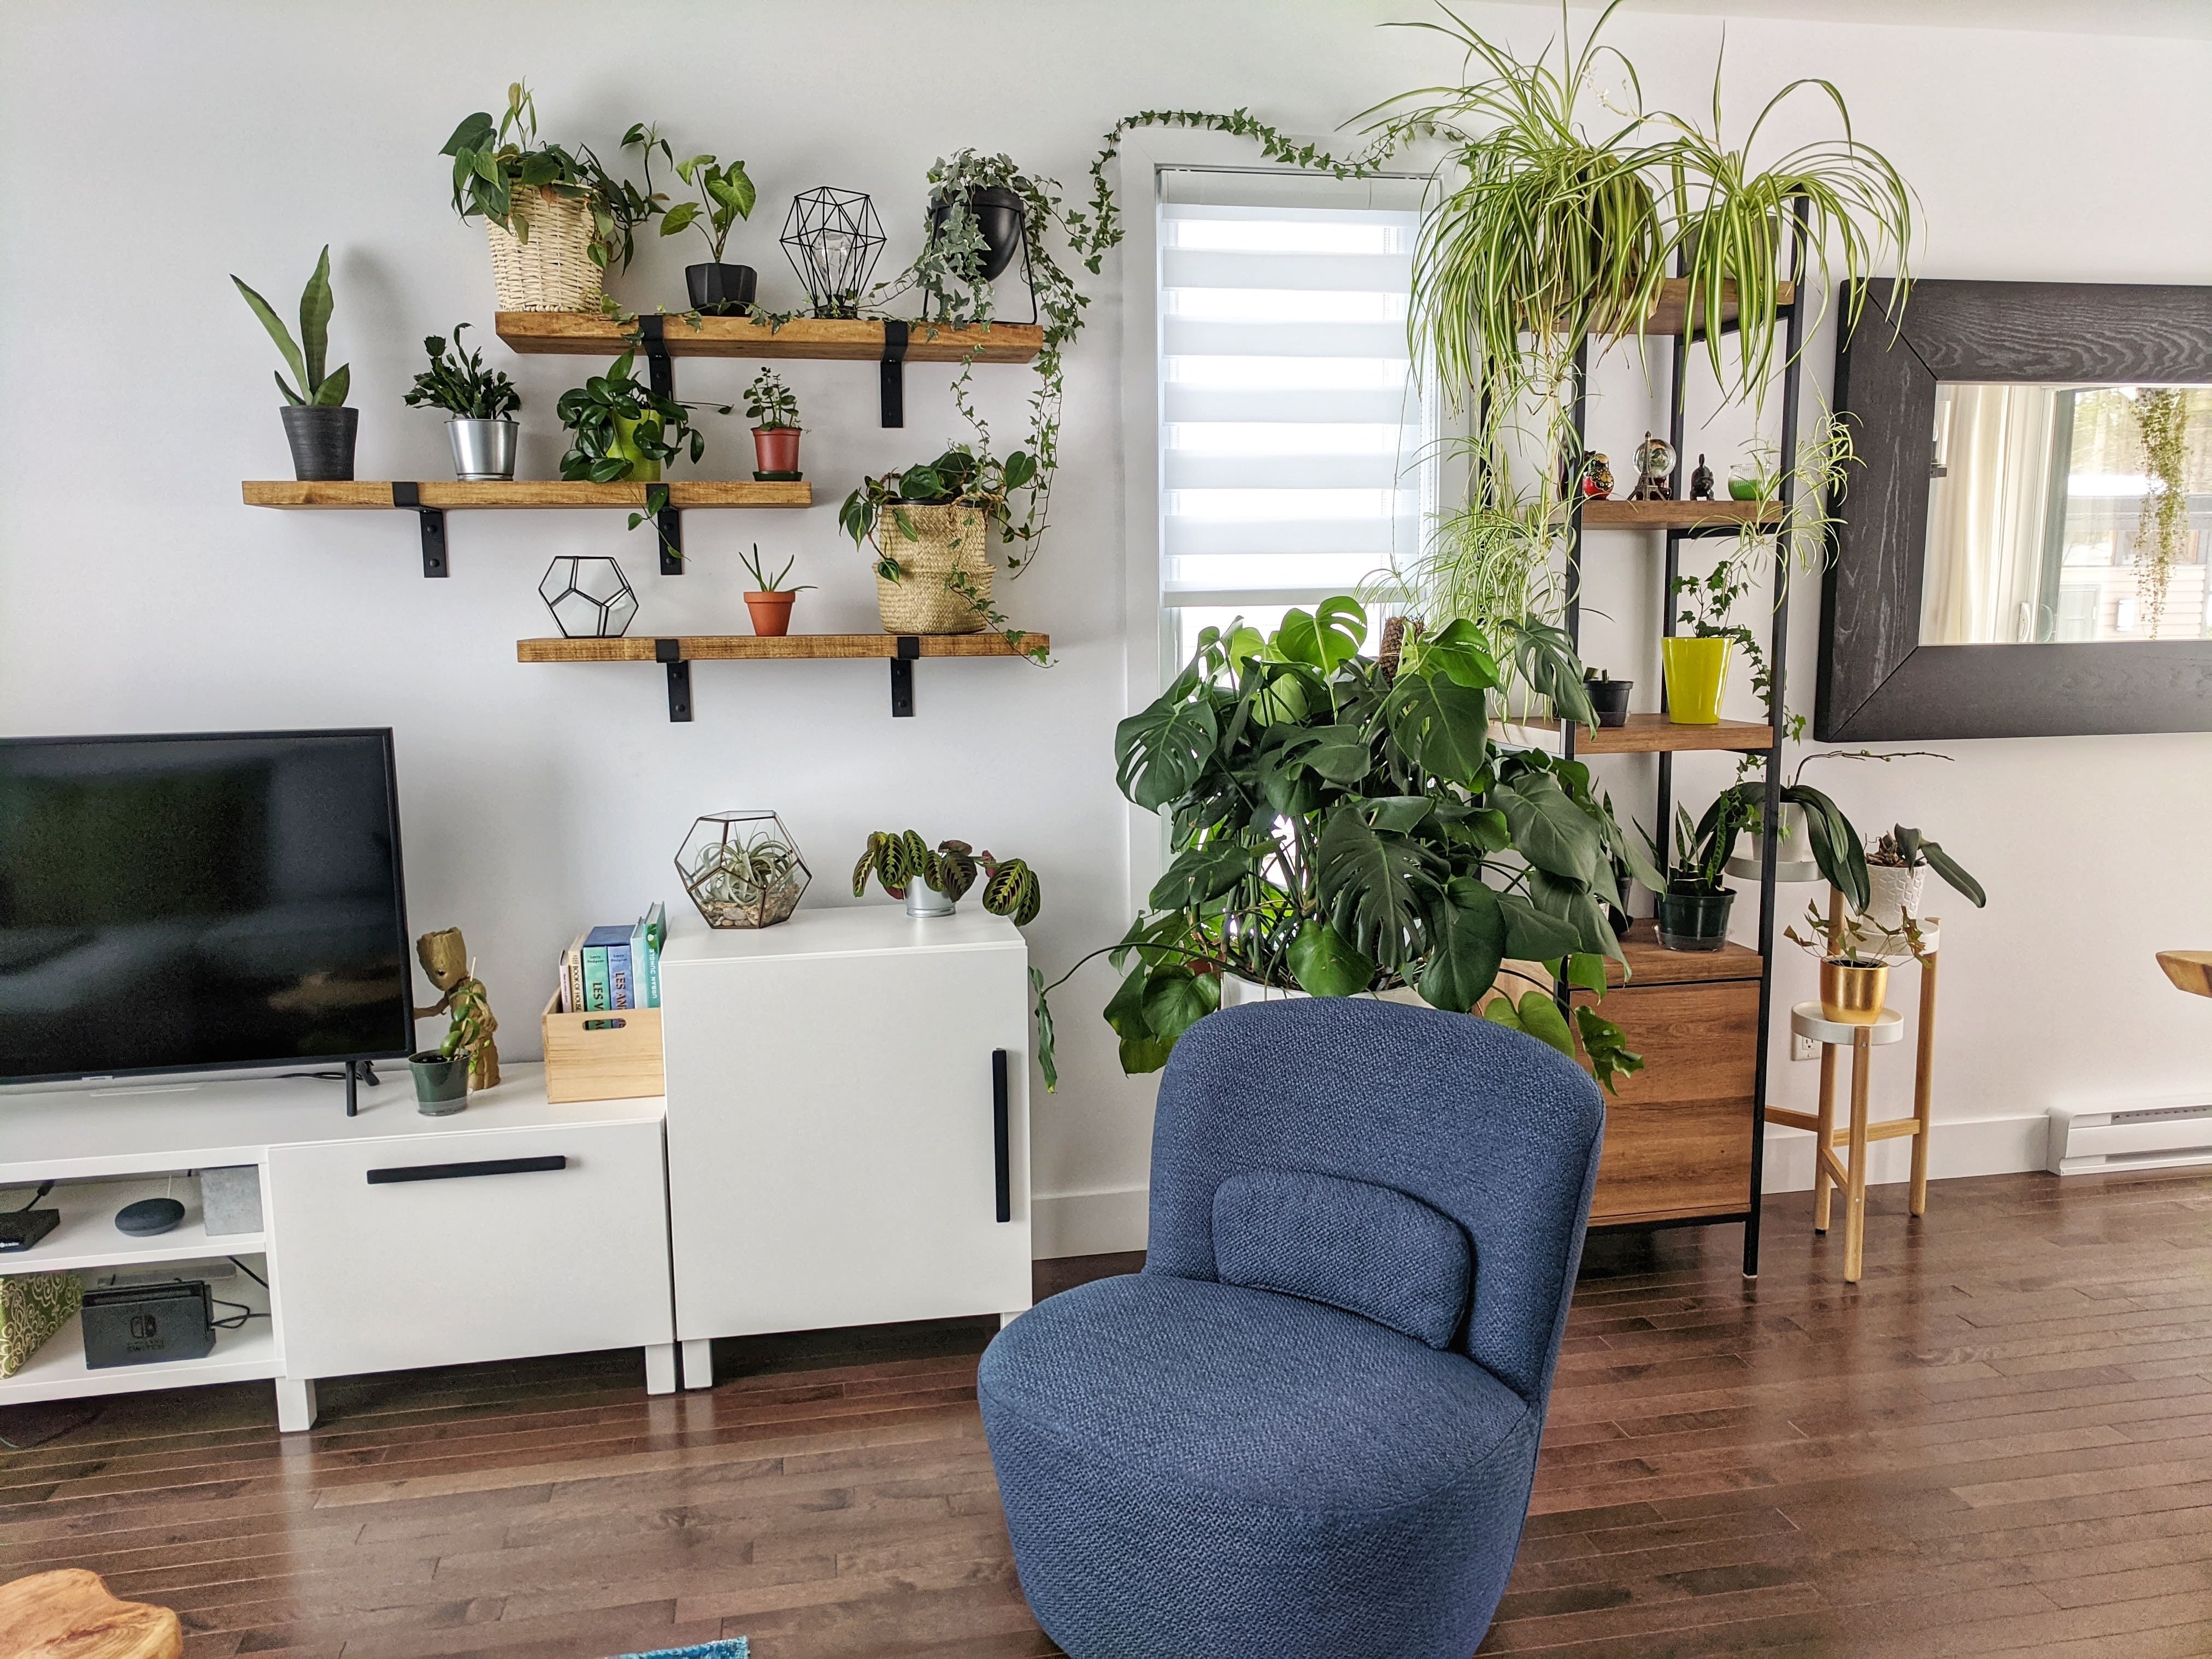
left=270, top=1117, right=670, bottom=1378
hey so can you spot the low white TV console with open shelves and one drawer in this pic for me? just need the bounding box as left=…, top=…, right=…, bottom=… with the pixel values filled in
left=0, top=1066, right=677, bottom=1431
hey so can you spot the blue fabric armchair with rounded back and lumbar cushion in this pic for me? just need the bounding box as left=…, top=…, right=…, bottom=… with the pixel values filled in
left=978, top=998, right=1604, bottom=1659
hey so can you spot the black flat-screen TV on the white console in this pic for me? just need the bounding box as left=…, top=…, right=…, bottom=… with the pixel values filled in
left=0, top=730, right=414, bottom=1081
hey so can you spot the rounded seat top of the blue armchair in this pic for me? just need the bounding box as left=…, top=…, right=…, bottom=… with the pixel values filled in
left=978, top=1272, right=1535, bottom=1515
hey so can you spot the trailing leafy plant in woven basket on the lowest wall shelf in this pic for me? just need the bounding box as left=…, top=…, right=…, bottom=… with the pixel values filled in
left=838, top=445, right=1035, bottom=635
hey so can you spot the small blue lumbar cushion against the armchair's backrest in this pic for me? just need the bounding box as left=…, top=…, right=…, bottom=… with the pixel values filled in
left=1214, top=1170, right=1473, bottom=1347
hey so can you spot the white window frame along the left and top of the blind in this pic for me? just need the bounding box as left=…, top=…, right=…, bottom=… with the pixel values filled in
left=1115, top=128, right=1433, bottom=916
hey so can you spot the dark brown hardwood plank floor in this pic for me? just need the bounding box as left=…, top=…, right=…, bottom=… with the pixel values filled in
left=0, top=1172, right=2212, bottom=1659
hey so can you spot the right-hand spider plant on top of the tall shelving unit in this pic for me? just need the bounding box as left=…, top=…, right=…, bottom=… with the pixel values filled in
left=1663, top=69, right=1914, bottom=403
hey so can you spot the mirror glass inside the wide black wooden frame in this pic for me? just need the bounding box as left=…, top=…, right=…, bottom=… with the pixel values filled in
left=1920, top=380, right=2212, bottom=646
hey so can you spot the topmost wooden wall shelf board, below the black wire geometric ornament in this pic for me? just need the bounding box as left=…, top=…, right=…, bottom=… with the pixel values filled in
left=496, top=312, right=1044, bottom=363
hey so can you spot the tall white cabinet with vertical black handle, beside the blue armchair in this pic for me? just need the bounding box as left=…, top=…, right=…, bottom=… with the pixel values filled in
left=661, top=901, right=1031, bottom=1354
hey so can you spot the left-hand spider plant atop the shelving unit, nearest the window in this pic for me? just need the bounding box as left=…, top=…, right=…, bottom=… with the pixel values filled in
left=1367, top=0, right=1668, bottom=425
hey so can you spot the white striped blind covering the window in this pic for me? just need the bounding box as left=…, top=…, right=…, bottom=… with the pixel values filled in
left=1157, top=168, right=1436, bottom=673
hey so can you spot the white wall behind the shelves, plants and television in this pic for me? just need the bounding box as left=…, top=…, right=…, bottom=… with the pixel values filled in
left=0, top=0, right=2212, bottom=1250
